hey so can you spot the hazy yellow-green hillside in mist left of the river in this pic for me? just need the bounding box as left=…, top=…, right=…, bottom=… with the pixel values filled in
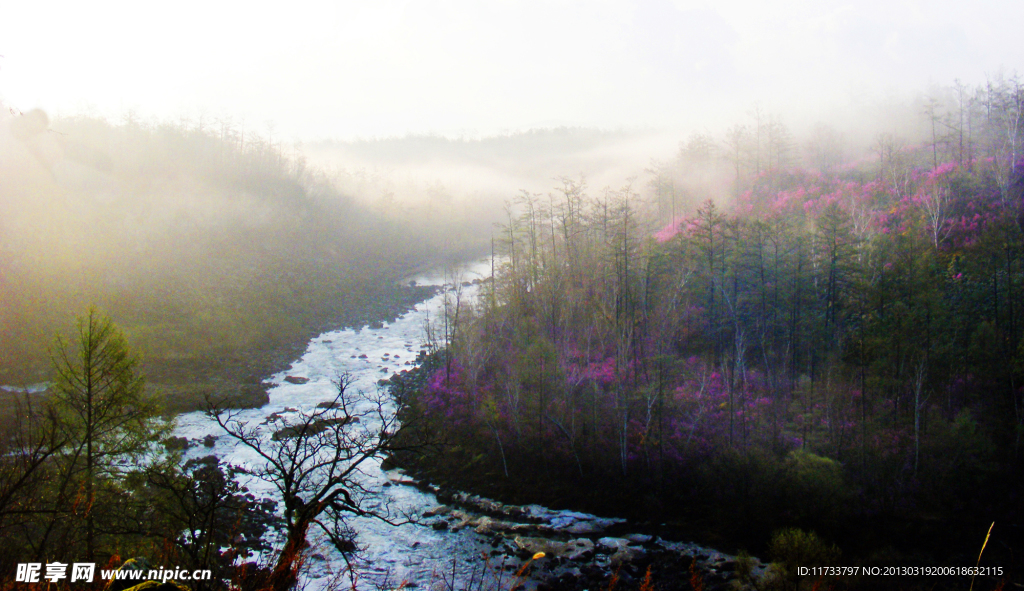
left=0, top=111, right=474, bottom=408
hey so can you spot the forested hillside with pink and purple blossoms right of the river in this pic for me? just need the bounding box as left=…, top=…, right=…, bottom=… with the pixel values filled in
left=391, top=75, right=1024, bottom=577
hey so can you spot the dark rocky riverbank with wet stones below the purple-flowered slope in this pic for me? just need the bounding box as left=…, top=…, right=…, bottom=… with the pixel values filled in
left=388, top=469, right=768, bottom=591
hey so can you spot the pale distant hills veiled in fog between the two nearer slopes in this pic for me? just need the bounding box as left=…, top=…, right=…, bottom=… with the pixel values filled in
left=302, top=127, right=675, bottom=223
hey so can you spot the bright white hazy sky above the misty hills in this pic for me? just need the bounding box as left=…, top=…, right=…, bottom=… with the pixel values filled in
left=0, top=0, right=1024, bottom=139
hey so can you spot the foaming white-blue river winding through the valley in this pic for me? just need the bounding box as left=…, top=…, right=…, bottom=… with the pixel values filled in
left=174, top=263, right=516, bottom=589
